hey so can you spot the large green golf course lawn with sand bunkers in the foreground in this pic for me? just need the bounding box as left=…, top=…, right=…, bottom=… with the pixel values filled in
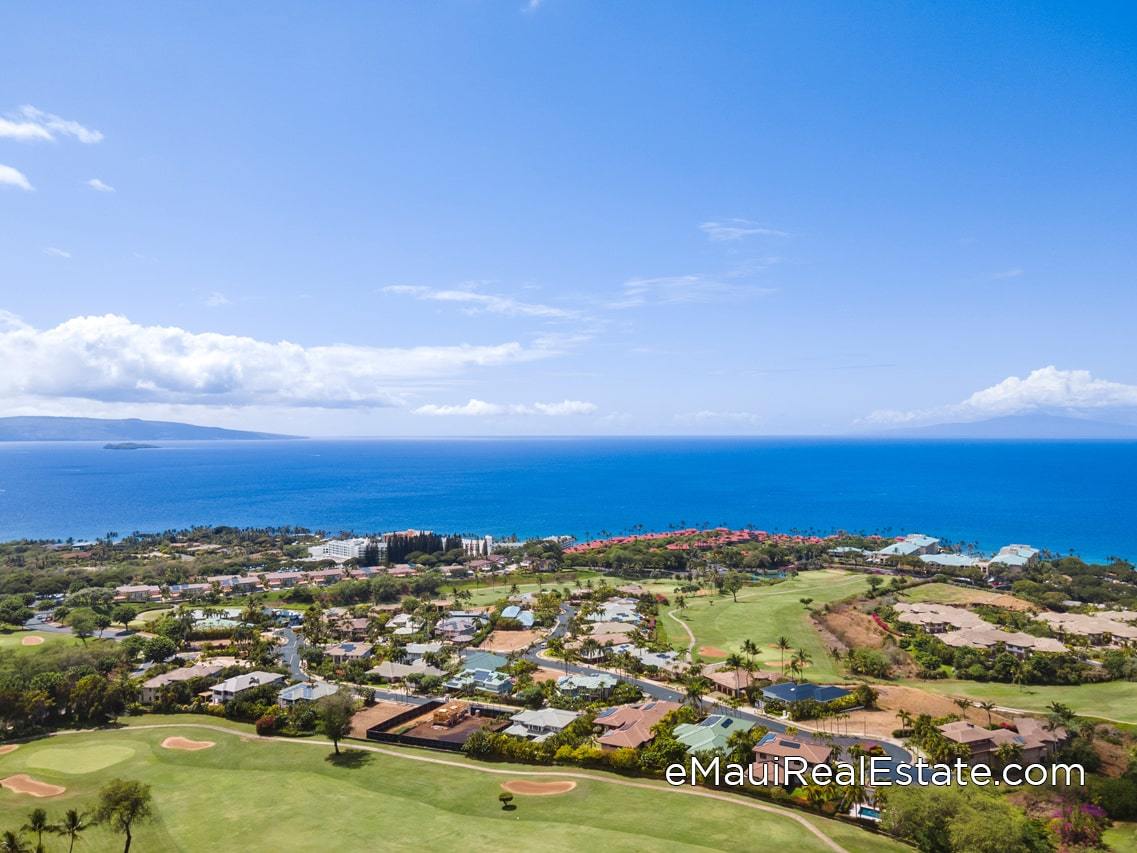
left=0, top=717, right=902, bottom=853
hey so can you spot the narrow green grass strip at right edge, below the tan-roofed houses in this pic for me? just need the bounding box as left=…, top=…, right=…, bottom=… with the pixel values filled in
left=905, top=679, right=1137, bottom=724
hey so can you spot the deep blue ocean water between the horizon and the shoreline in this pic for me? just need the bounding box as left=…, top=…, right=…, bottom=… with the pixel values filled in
left=0, top=438, right=1137, bottom=558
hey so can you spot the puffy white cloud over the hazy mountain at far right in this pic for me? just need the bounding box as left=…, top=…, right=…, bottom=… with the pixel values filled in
left=865, top=365, right=1137, bottom=424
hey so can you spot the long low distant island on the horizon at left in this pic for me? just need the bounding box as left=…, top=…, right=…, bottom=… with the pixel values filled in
left=0, top=416, right=300, bottom=450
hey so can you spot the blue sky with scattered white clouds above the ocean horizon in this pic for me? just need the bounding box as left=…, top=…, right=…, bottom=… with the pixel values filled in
left=0, top=0, right=1137, bottom=434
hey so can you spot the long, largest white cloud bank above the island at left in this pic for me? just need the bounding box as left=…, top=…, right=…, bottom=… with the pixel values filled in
left=0, top=312, right=556, bottom=408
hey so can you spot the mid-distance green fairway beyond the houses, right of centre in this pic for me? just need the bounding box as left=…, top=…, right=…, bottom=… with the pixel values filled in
left=661, top=569, right=869, bottom=679
